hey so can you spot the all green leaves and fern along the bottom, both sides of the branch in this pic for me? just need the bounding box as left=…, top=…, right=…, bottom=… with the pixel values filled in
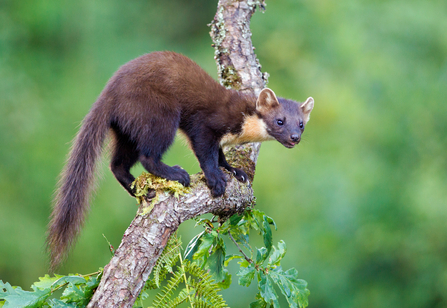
left=0, top=209, right=309, bottom=308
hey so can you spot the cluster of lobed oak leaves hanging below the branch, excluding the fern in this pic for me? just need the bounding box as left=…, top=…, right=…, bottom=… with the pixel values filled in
left=185, top=209, right=309, bottom=308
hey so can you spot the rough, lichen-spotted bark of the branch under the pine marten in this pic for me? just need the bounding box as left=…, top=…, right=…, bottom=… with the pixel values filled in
left=88, top=0, right=266, bottom=307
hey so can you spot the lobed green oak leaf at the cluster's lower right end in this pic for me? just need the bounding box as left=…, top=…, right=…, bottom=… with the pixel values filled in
left=269, top=266, right=310, bottom=308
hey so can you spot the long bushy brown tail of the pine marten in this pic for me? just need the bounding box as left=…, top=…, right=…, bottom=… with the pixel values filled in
left=47, top=96, right=109, bottom=271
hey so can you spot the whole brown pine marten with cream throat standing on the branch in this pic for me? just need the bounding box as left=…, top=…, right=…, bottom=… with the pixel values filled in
left=47, top=52, right=314, bottom=269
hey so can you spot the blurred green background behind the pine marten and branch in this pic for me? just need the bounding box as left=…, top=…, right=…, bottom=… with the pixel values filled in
left=0, top=0, right=447, bottom=307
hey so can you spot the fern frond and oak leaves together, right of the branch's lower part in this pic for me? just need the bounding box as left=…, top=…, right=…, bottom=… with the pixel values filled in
left=143, top=213, right=309, bottom=308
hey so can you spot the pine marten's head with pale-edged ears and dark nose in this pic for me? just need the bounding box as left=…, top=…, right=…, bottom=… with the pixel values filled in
left=256, top=88, right=314, bottom=148
